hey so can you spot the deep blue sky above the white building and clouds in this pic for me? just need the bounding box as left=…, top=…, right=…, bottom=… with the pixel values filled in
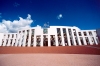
left=0, top=0, right=100, bottom=32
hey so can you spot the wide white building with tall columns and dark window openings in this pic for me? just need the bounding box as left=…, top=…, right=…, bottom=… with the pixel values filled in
left=0, top=26, right=99, bottom=47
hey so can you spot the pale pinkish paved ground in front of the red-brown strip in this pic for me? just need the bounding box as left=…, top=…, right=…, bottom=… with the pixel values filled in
left=0, top=54, right=100, bottom=66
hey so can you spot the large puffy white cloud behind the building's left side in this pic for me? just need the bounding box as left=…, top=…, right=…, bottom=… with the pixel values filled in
left=0, top=14, right=33, bottom=33
